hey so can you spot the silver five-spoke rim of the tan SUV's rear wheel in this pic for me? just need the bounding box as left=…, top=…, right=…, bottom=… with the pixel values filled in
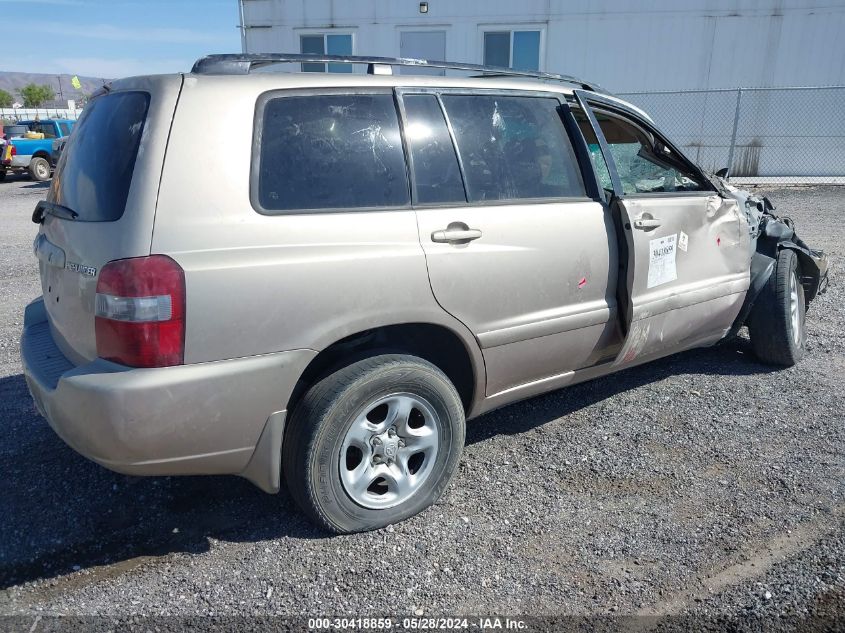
left=339, top=393, right=442, bottom=509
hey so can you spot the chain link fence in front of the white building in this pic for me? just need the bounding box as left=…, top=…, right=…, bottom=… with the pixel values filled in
left=618, top=86, right=845, bottom=184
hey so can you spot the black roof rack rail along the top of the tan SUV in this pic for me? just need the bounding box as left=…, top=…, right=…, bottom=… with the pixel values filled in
left=191, top=53, right=606, bottom=92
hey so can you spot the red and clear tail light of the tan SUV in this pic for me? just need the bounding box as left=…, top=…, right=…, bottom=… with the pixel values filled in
left=94, top=255, right=185, bottom=367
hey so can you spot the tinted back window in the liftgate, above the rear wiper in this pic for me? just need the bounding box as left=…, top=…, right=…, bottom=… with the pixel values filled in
left=48, top=92, right=150, bottom=222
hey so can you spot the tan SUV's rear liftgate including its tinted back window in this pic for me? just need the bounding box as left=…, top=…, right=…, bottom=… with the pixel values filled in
left=34, top=75, right=181, bottom=363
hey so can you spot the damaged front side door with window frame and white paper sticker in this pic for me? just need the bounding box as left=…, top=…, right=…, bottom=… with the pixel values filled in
left=576, top=92, right=751, bottom=366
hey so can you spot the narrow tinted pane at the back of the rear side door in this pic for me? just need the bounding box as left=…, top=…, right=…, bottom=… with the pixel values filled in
left=403, top=95, right=466, bottom=204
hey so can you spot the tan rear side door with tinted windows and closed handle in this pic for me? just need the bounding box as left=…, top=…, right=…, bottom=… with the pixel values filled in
left=400, top=90, right=621, bottom=395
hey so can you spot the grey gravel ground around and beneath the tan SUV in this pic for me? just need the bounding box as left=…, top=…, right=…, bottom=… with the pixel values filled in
left=0, top=178, right=845, bottom=630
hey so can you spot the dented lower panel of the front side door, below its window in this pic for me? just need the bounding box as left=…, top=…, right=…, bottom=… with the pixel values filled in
left=616, top=195, right=749, bottom=366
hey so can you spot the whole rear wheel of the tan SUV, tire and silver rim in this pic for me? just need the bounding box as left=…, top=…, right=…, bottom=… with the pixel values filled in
left=282, top=354, right=465, bottom=533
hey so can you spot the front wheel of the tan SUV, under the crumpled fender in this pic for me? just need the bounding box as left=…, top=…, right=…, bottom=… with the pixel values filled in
left=748, top=248, right=807, bottom=367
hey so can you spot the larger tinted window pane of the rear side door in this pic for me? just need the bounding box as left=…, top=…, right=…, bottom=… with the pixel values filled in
left=443, top=95, right=586, bottom=202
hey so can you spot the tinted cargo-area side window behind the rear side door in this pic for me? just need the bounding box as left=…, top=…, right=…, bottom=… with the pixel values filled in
left=253, top=94, right=410, bottom=214
